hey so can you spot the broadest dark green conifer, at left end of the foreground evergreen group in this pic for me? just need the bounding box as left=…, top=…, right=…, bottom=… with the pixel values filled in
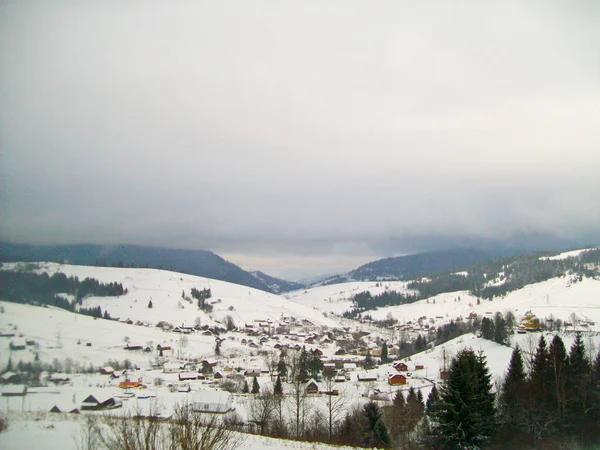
left=432, top=349, right=494, bottom=448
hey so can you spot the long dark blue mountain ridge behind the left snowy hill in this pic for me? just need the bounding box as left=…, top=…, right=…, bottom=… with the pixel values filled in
left=0, top=243, right=298, bottom=293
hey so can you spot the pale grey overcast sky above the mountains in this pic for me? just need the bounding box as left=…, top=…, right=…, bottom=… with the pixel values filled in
left=0, top=0, right=600, bottom=276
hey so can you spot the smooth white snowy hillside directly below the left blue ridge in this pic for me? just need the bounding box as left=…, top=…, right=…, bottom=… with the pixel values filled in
left=5, top=263, right=336, bottom=327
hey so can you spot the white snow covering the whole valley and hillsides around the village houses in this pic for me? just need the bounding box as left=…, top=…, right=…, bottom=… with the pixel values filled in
left=0, top=263, right=600, bottom=449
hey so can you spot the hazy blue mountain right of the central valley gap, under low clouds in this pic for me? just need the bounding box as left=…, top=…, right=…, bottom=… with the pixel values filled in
left=316, top=249, right=500, bottom=286
